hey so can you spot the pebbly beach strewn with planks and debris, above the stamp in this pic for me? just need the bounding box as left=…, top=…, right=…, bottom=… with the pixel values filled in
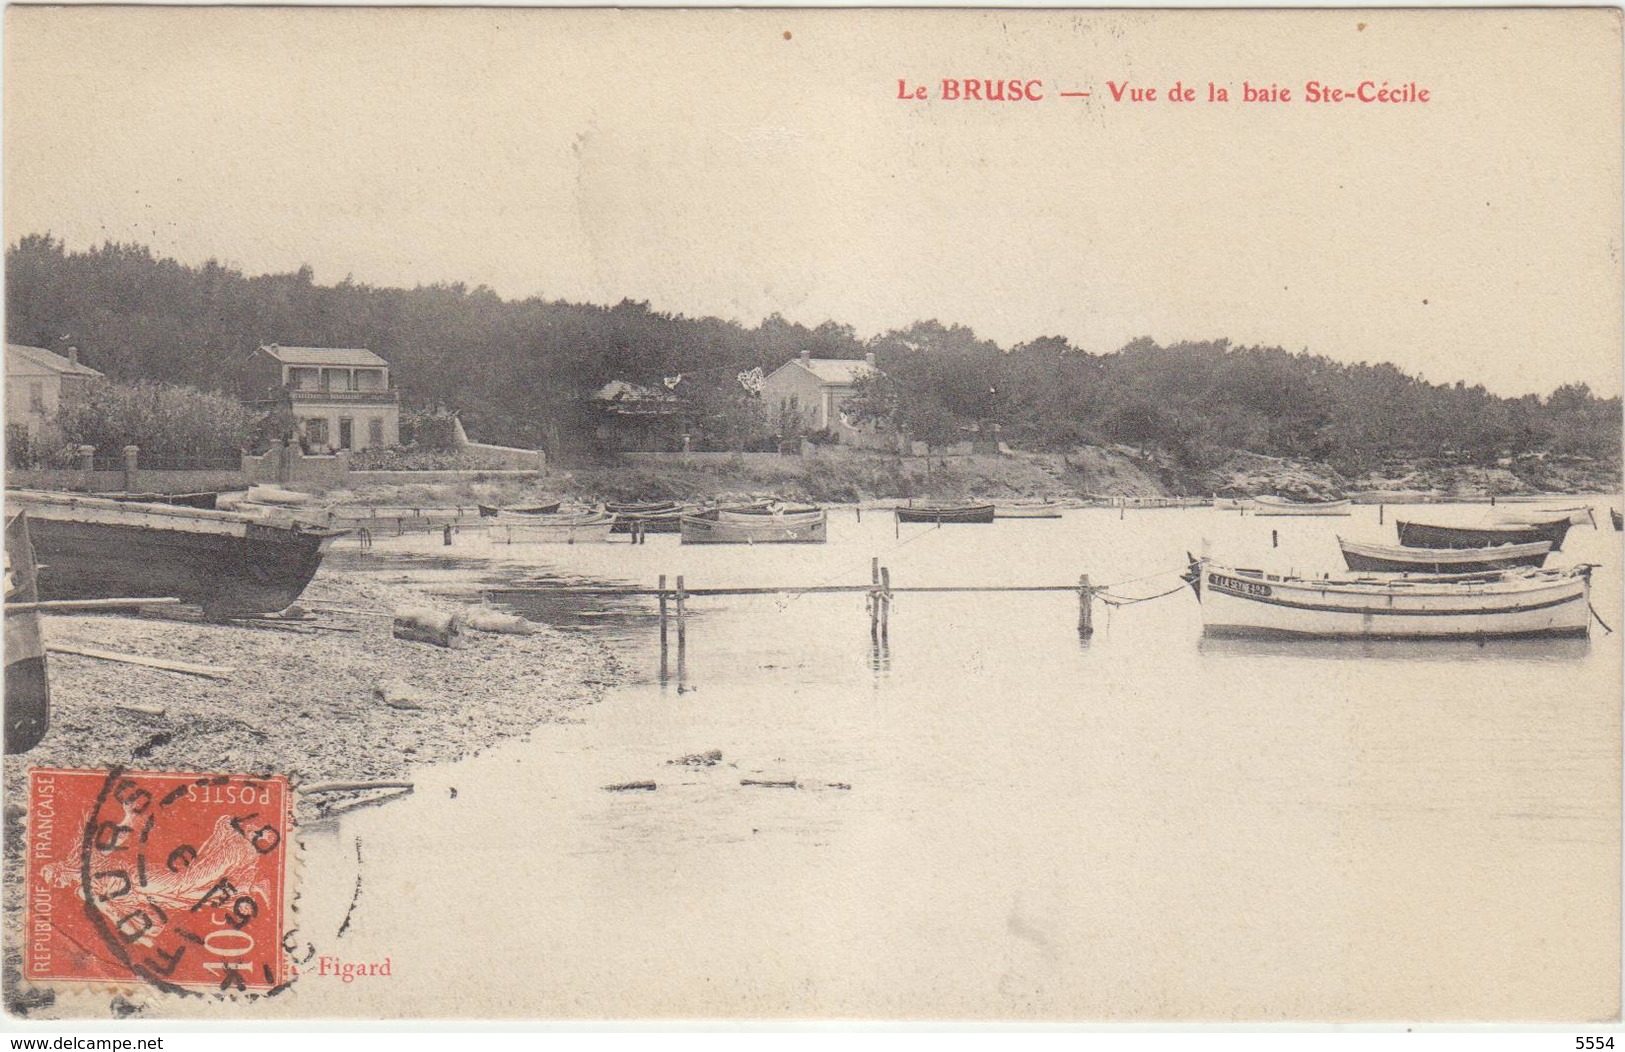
left=3, top=556, right=626, bottom=1018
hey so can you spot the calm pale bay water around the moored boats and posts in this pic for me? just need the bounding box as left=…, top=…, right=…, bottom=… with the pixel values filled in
left=265, top=502, right=1622, bottom=1019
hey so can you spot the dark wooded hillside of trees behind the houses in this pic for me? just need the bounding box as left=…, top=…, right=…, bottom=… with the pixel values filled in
left=5, top=234, right=1620, bottom=472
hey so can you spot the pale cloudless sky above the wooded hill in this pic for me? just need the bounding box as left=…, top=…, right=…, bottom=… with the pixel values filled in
left=5, top=7, right=1625, bottom=395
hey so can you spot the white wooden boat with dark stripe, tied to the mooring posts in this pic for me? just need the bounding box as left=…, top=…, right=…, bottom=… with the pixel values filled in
left=1186, top=559, right=1591, bottom=639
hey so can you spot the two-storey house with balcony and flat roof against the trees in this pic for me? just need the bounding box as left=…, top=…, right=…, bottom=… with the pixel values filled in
left=249, top=343, right=401, bottom=452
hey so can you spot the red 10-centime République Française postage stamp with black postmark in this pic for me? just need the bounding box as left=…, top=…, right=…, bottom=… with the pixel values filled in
left=24, top=767, right=293, bottom=993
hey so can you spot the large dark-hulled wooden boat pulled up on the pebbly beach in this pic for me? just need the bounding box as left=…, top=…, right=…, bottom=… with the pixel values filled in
left=7, top=489, right=343, bottom=618
